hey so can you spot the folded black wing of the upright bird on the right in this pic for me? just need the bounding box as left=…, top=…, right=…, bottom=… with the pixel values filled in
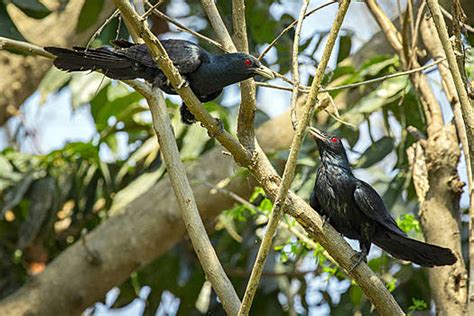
left=354, top=180, right=406, bottom=236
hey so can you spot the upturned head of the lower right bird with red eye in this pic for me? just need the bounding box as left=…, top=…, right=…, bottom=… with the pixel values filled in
left=309, top=127, right=350, bottom=168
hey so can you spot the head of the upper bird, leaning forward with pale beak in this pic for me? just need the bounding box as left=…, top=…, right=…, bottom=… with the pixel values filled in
left=224, top=53, right=275, bottom=79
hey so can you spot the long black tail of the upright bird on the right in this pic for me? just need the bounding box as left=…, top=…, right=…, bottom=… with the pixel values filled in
left=373, top=232, right=457, bottom=267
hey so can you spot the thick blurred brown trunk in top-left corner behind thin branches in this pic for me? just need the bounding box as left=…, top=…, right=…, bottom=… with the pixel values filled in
left=0, top=0, right=114, bottom=125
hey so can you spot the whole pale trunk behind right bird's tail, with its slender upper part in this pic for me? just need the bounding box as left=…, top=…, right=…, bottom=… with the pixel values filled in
left=366, top=0, right=467, bottom=315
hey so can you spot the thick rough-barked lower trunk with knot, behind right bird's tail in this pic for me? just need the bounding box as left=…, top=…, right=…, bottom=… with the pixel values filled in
left=409, top=125, right=467, bottom=315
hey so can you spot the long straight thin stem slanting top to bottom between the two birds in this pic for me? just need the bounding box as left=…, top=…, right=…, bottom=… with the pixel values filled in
left=239, top=0, right=350, bottom=315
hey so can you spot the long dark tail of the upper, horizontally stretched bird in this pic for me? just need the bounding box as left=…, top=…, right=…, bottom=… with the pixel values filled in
left=44, top=47, right=154, bottom=81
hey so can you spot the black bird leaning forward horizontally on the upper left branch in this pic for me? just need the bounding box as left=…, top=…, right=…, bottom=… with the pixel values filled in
left=44, top=39, right=274, bottom=124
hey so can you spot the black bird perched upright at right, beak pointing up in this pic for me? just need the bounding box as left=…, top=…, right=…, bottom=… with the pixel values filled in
left=309, top=128, right=457, bottom=270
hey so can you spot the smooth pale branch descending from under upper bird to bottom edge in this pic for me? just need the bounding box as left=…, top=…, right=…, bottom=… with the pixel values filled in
left=128, top=82, right=240, bottom=315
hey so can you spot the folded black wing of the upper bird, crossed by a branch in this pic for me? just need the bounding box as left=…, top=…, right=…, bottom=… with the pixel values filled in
left=113, top=40, right=208, bottom=74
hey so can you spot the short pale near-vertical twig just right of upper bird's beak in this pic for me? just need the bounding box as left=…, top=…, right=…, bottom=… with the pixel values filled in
left=290, top=0, right=309, bottom=130
